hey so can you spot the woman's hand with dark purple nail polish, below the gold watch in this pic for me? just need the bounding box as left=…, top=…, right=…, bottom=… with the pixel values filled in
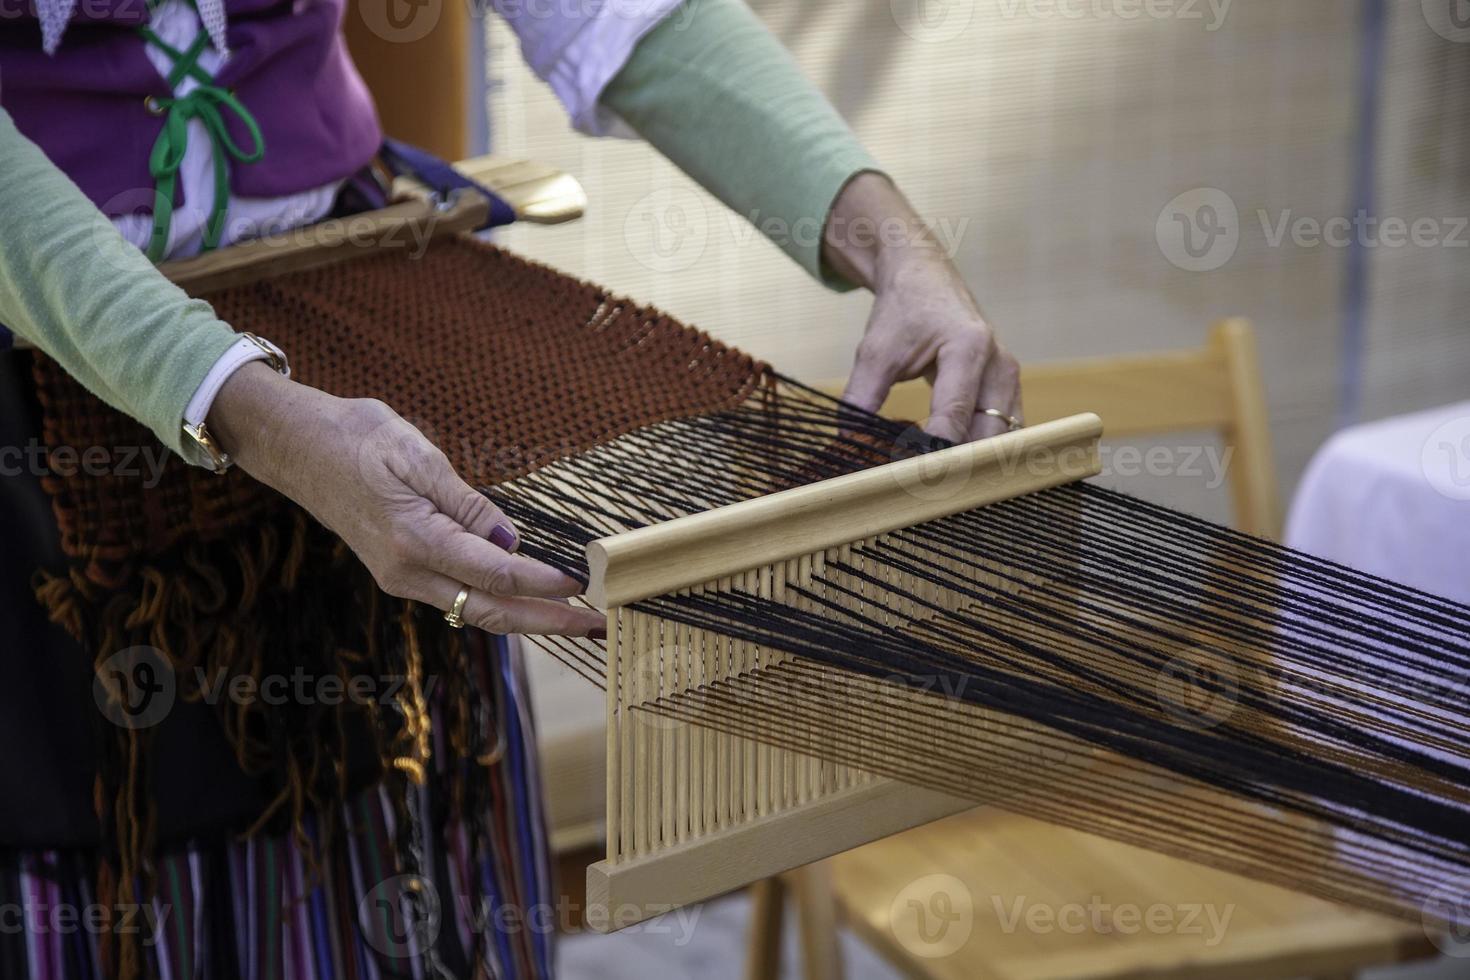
left=207, top=363, right=604, bottom=636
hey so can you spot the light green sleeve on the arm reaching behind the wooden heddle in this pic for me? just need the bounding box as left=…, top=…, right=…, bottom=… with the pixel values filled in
left=601, top=0, right=879, bottom=288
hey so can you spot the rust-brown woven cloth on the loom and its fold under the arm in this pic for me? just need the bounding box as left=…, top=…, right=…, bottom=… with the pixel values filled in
left=37, top=238, right=766, bottom=585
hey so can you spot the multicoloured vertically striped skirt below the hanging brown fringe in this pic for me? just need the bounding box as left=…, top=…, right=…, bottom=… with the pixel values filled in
left=0, top=630, right=557, bottom=980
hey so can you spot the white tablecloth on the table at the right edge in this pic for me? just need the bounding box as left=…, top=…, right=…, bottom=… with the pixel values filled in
left=1286, top=401, right=1470, bottom=602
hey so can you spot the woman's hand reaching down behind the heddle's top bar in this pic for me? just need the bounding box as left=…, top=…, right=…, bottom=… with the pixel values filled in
left=822, top=173, right=1022, bottom=442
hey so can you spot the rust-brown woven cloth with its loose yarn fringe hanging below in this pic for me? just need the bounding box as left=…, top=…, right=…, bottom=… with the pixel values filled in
left=22, top=239, right=775, bottom=977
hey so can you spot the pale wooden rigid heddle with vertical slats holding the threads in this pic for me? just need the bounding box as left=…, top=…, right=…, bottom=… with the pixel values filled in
left=587, top=414, right=1103, bottom=932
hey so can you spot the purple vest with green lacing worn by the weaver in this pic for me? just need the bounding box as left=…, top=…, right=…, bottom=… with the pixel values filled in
left=0, top=0, right=382, bottom=215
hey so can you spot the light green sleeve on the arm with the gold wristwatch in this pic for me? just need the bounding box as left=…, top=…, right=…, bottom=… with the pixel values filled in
left=0, top=109, right=237, bottom=463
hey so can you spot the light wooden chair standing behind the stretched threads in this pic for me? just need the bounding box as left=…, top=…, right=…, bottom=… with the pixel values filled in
left=747, top=320, right=1435, bottom=980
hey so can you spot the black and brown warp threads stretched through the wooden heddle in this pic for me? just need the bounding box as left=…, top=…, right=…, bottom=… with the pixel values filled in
left=497, top=382, right=1470, bottom=921
